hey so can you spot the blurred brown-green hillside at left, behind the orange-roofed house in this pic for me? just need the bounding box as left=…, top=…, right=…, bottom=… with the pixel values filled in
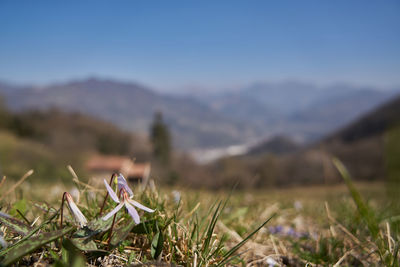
left=0, top=99, right=150, bottom=182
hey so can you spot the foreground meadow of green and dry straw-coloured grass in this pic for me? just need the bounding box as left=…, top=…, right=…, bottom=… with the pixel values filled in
left=0, top=164, right=400, bottom=266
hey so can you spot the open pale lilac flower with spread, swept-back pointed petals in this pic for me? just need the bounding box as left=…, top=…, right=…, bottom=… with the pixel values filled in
left=103, top=179, right=154, bottom=224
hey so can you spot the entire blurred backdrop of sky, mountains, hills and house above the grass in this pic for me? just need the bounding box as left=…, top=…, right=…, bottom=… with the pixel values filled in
left=0, top=1, right=400, bottom=189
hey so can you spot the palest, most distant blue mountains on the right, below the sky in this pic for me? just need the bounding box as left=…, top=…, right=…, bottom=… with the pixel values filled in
left=203, top=81, right=400, bottom=142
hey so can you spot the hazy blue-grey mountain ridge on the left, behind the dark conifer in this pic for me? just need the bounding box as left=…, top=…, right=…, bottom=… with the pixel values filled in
left=0, top=79, right=252, bottom=148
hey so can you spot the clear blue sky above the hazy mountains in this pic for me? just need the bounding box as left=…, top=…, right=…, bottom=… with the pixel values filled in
left=0, top=0, right=400, bottom=91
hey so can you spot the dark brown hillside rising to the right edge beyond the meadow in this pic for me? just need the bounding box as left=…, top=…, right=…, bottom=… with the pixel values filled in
left=213, top=94, right=400, bottom=187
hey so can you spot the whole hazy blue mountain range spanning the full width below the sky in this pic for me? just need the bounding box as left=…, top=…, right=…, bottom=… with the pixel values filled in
left=0, top=78, right=400, bottom=150
